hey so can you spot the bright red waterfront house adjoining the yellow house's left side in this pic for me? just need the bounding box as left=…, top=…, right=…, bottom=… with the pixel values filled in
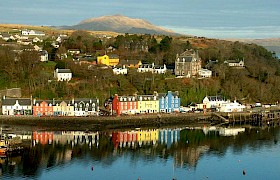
left=112, top=94, right=138, bottom=116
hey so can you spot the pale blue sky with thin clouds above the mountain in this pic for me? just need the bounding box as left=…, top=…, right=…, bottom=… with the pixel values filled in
left=0, top=0, right=280, bottom=38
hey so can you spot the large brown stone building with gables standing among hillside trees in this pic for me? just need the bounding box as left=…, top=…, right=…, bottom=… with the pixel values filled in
left=175, top=49, right=201, bottom=77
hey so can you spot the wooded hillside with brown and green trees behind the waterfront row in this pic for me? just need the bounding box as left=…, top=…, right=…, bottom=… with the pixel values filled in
left=0, top=25, right=280, bottom=105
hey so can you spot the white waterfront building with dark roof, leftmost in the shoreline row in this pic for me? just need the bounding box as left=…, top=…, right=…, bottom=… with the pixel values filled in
left=2, top=96, right=32, bottom=115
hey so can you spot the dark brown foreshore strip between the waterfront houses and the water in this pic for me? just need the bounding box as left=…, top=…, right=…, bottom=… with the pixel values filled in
left=0, top=113, right=211, bottom=131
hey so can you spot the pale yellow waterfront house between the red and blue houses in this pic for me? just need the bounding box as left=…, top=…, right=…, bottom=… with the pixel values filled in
left=137, top=94, right=159, bottom=114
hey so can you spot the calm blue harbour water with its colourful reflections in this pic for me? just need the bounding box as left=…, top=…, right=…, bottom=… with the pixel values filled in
left=1, top=127, right=280, bottom=180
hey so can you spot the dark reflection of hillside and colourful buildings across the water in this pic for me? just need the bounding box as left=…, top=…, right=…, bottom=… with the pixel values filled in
left=0, top=127, right=279, bottom=178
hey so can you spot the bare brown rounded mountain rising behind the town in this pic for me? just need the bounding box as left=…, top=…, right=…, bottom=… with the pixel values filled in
left=60, top=15, right=178, bottom=35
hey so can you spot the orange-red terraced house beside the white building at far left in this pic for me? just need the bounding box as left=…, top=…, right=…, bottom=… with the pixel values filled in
left=33, top=100, right=53, bottom=116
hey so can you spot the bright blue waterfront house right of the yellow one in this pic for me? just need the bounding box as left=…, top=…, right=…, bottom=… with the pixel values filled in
left=158, top=91, right=180, bottom=113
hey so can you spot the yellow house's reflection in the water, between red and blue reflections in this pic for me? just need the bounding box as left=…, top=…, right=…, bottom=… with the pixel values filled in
left=137, top=129, right=159, bottom=146
